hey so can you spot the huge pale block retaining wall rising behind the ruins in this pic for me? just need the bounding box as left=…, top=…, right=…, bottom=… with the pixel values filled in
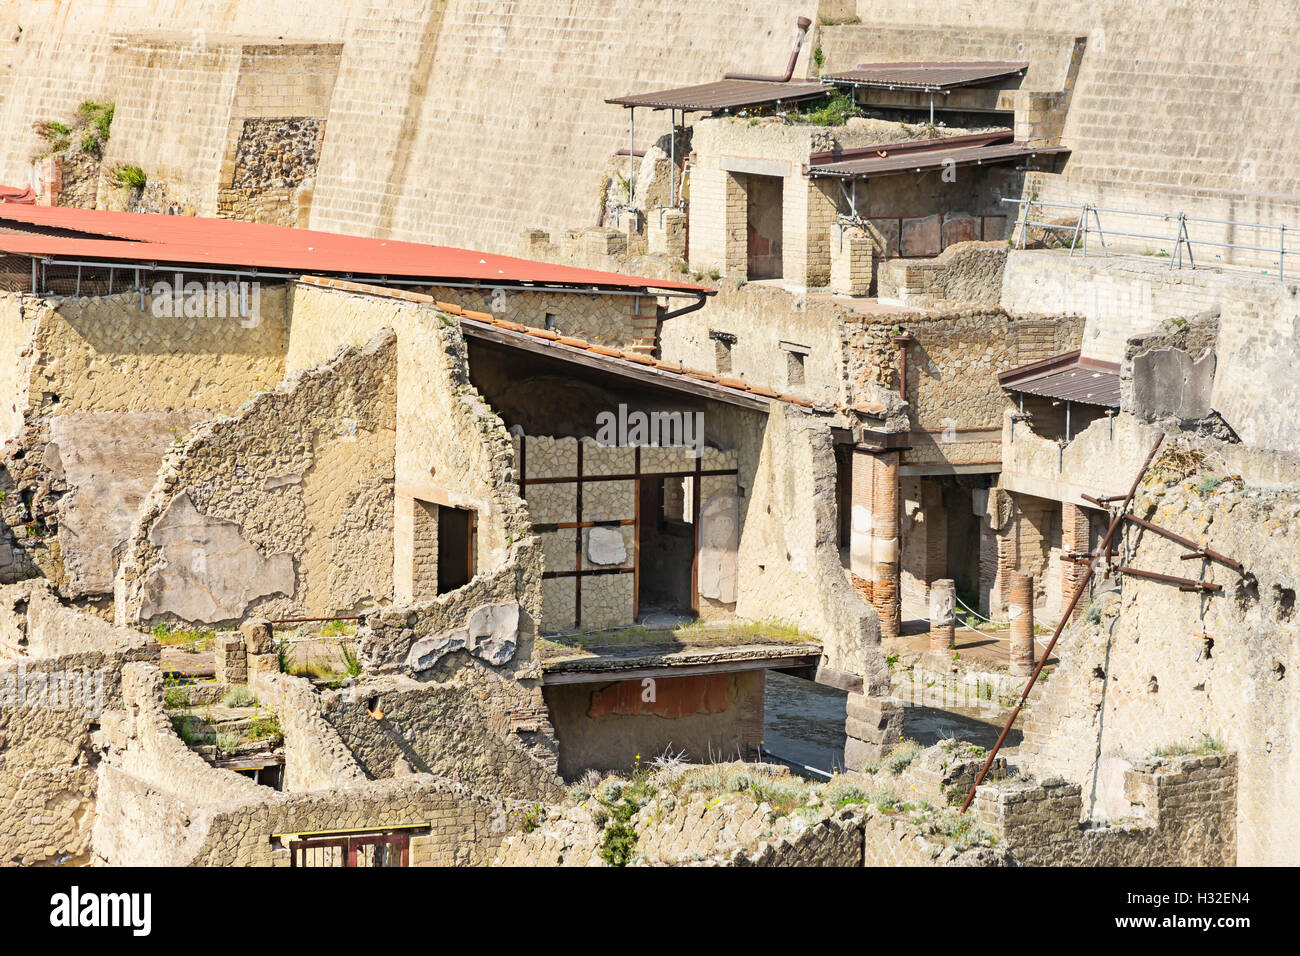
left=12, top=0, right=1300, bottom=251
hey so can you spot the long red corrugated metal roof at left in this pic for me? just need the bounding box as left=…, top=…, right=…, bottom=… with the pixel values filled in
left=0, top=203, right=714, bottom=295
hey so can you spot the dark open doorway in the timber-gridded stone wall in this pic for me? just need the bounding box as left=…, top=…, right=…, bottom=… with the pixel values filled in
left=637, top=477, right=696, bottom=619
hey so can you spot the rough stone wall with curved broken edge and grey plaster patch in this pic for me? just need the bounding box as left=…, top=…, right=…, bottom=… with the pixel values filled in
left=117, top=332, right=397, bottom=623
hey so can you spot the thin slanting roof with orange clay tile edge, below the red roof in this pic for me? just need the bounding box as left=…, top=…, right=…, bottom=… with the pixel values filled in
left=298, top=276, right=813, bottom=408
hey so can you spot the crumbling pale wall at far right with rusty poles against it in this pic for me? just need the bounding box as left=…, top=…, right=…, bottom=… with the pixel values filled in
left=1022, top=446, right=1300, bottom=865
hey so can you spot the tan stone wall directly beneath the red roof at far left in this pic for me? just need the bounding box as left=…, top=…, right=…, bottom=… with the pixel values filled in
left=0, top=287, right=285, bottom=598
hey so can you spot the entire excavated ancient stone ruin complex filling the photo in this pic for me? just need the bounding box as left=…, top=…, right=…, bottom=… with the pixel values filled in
left=0, top=0, right=1284, bottom=884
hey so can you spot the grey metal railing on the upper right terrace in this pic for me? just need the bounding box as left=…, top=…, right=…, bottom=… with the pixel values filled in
left=1002, top=199, right=1300, bottom=281
